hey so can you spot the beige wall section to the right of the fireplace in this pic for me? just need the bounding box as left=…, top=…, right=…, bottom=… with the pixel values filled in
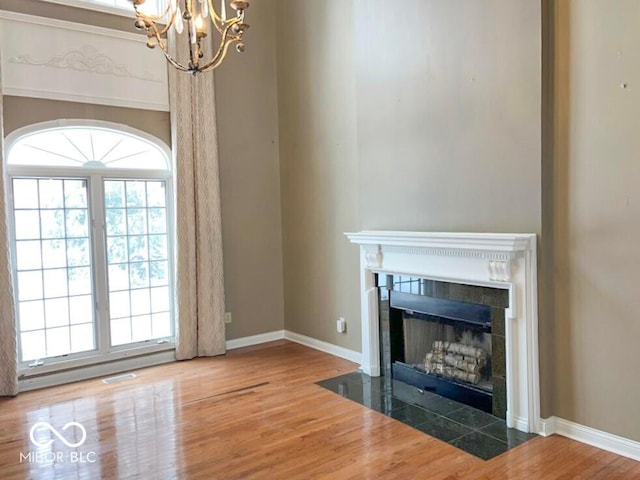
left=554, top=0, right=640, bottom=441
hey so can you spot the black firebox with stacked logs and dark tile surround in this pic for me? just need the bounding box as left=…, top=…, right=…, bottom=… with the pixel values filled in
left=378, top=275, right=507, bottom=418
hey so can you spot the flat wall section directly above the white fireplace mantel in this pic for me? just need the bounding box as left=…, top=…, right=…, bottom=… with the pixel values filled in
left=355, top=0, right=541, bottom=233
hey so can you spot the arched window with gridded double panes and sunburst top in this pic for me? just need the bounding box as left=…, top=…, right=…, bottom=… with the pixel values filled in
left=5, top=120, right=174, bottom=369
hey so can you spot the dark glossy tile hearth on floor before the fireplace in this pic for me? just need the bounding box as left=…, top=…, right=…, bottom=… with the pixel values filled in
left=318, top=372, right=536, bottom=460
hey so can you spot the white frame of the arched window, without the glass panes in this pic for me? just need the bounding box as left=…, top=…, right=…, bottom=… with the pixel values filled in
left=5, top=120, right=177, bottom=378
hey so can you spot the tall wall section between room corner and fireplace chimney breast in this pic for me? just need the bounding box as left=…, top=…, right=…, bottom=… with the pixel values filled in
left=277, top=0, right=361, bottom=351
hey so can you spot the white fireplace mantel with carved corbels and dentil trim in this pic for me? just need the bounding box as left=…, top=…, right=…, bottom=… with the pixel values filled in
left=346, top=231, right=540, bottom=433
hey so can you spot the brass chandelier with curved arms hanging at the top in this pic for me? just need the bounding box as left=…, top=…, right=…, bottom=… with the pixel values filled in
left=132, top=0, right=249, bottom=75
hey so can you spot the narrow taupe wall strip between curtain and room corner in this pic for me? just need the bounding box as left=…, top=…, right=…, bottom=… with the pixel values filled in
left=215, top=0, right=284, bottom=339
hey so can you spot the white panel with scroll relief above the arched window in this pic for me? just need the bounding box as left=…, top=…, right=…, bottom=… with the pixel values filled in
left=0, top=11, right=169, bottom=111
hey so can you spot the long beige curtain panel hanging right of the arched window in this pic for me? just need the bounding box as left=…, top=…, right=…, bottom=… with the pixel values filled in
left=169, top=31, right=225, bottom=360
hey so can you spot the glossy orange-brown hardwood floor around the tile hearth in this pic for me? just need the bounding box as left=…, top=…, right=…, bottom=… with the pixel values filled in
left=0, top=341, right=640, bottom=480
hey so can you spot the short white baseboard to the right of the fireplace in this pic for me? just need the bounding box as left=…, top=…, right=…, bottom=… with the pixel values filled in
left=540, top=417, right=640, bottom=460
